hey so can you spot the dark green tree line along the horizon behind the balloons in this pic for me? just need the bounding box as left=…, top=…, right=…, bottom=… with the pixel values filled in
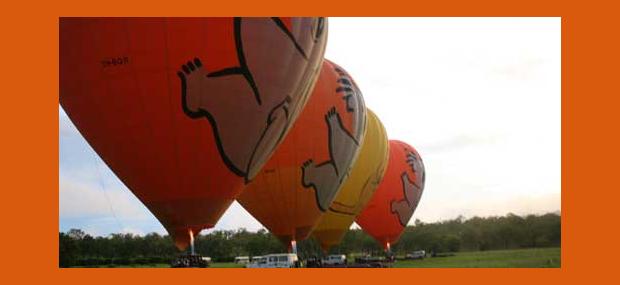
left=59, top=213, right=561, bottom=267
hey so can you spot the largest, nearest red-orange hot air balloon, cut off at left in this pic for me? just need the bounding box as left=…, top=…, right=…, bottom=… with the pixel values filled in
left=60, top=18, right=327, bottom=249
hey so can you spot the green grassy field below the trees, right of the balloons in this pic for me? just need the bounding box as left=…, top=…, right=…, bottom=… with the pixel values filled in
left=394, top=248, right=561, bottom=268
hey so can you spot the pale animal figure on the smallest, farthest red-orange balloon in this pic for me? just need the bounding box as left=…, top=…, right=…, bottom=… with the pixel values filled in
left=391, top=150, right=426, bottom=227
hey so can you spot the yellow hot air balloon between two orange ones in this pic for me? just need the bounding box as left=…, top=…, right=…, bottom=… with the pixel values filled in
left=312, top=109, right=388, bottom=251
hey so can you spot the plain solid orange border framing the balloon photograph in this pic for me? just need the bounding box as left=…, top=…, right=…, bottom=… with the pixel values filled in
left=0, top=0, right=620, bottom=284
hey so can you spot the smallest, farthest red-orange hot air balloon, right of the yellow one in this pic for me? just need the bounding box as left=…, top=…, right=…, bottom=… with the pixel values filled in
left=356, top=140, right=426, bottom=250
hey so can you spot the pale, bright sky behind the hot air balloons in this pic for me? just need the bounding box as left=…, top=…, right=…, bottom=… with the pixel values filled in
left=59, top=18, right=561, bottom=235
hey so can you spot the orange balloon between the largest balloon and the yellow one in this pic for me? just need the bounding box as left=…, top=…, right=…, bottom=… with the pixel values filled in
left=238, top=60, right=366, bottom=244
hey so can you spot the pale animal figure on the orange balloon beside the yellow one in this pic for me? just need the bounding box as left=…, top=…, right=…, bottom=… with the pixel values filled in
left=301, top=65, right=366, bottom=211
